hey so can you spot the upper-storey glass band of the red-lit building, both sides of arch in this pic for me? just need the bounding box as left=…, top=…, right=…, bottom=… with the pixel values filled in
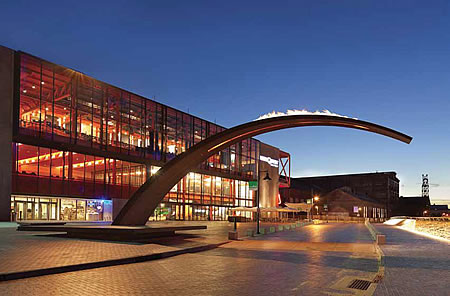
left=18, top=53, right=257, bottom=177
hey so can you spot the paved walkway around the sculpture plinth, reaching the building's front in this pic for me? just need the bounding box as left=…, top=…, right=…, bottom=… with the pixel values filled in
left=0, top=221, right=298, bottom=274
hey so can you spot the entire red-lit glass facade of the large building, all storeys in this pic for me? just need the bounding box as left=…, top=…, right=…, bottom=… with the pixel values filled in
left=12, top=53, right=259, bottom=221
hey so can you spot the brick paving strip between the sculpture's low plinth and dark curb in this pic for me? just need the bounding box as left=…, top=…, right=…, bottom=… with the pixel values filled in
left=0, top=222, right=223, bottom=273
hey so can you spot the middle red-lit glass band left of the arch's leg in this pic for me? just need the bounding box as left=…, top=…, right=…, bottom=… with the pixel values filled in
left=12, top=143, right=147, bottom=199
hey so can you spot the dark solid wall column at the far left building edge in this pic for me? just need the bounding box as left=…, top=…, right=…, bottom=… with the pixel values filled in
left=0, top=46, right=14, bottom=221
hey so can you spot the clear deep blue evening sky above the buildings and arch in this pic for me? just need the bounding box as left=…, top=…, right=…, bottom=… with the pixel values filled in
left=0, top=0, right=450, bottom=201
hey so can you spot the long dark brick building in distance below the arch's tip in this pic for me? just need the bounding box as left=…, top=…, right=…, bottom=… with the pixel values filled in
left=280, top=172, right=400, bottom=216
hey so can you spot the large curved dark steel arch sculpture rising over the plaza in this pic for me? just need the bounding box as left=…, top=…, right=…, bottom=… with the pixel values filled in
left=112, top=115, right=412, bottom=225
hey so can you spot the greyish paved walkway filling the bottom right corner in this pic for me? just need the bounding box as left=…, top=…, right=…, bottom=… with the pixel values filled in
left=374, top=224, right=450, bottom=296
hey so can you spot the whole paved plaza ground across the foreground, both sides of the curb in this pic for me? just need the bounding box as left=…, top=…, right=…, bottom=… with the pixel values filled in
left=0, top=222, right=450, bottom=296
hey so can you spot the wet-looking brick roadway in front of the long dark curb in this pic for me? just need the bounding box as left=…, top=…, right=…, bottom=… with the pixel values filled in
left=0, top=224, right=384, bottom=295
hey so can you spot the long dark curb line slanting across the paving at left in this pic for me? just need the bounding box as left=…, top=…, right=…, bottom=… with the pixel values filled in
left=0, top=241, right=229, bottom=282
